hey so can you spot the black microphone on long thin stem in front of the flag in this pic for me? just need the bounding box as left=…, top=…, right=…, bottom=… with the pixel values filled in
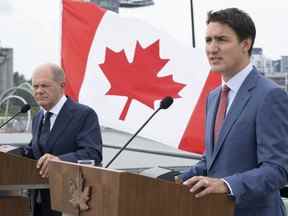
left=105, top=96, right=173, bottom=168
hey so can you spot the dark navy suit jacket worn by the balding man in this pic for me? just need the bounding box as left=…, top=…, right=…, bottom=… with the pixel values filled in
left=24, top=98, right=102, bottom=164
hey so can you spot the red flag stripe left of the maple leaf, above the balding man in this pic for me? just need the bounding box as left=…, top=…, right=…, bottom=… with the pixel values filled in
left=61, top=0, right=105, bottom=100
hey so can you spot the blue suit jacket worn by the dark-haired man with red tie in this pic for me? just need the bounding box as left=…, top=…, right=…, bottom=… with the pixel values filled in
left=182, top=68, right=288, bottom=216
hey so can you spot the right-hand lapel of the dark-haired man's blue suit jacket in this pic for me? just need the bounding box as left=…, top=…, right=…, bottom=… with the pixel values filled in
left=208, top=69, right=257, bottom=169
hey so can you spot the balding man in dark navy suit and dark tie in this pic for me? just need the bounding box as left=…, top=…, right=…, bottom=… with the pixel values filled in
left=23, top=61, right=102, bottom=216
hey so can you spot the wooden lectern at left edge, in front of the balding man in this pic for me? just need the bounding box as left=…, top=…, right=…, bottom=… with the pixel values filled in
left=0, top=152, right=48, bottom=216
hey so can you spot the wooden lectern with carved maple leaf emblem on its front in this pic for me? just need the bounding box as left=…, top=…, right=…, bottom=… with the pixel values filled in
left=48, top=161, right=234, bottom=216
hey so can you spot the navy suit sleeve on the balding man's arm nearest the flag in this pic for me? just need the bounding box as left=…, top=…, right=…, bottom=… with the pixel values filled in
left=58, top=108, right=102, bottom=165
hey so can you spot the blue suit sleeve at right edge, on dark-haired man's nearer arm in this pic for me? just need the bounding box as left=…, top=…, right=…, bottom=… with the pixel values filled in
left=224, top=89, right=288, bottom=203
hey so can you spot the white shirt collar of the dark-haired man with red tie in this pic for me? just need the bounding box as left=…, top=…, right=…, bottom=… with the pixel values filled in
left=222, top=63, right=253, bottom=93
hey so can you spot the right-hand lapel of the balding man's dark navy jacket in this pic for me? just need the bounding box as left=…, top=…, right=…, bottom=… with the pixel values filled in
left=46, top=98, right=73, bottom=152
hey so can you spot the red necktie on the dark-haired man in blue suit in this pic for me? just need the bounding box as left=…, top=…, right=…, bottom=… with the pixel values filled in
left=214, top=85, right=230, bottom=144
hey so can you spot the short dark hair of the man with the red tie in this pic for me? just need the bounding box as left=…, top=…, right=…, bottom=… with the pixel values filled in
left=206, top=8, right=256, bottom=56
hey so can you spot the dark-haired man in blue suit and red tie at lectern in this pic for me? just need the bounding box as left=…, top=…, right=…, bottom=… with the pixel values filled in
left=181, top=8, right=288, bottom=216
